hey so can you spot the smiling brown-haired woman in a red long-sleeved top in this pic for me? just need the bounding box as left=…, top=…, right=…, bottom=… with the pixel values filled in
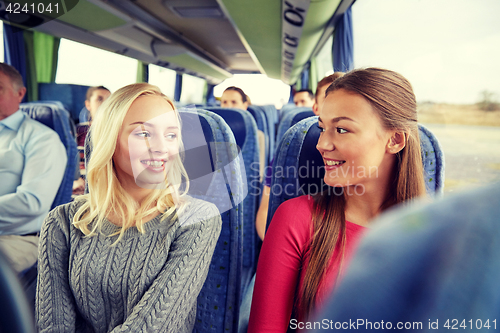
left=248, top=68, right=425, bottom=333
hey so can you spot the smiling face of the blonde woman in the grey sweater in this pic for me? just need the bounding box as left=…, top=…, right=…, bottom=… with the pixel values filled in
left=113, top=96, right=180, bottom=189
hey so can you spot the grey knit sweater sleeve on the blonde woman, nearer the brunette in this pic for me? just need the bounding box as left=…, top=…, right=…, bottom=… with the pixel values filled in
left=111, top=206, right=222, bottom=333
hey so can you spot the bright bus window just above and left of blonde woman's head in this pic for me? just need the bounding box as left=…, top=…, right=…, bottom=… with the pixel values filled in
left=56, top=39, right=137, bottom=92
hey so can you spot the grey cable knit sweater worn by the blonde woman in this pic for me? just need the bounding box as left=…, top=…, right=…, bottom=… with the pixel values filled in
left=36, top=198, right=221, bottom=333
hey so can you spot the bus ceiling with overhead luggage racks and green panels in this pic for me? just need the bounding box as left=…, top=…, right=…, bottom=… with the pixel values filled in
left=0, top=0, right=355, bottom=84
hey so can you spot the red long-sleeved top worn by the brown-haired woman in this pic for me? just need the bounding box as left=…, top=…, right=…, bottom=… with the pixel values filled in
left=248, top=196, right=366, bottom=333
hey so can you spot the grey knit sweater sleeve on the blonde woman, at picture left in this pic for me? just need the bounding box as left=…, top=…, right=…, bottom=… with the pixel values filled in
left=36, top=205, right=76, bottom=333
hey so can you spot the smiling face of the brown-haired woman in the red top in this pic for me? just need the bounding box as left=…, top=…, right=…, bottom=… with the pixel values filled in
left=316, top=89, right=394, bottom=187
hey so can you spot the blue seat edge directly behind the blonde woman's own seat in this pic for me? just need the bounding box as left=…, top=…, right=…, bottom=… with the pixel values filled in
left=202, top=108, right=261, bottom=298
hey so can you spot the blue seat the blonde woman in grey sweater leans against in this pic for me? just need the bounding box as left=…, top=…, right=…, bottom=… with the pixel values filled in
left=180, top=110, right=246, bottom=333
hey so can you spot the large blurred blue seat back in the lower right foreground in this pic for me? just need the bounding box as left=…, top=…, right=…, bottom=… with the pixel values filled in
left=310, top=183, right=500, bottom=332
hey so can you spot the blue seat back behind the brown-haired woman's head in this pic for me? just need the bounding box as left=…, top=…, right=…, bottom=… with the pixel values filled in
left=267, top=117, right=444, bottom=227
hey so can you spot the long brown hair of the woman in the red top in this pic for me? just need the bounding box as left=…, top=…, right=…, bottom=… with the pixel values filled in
left=297, top=68, right=425, bottom=319
